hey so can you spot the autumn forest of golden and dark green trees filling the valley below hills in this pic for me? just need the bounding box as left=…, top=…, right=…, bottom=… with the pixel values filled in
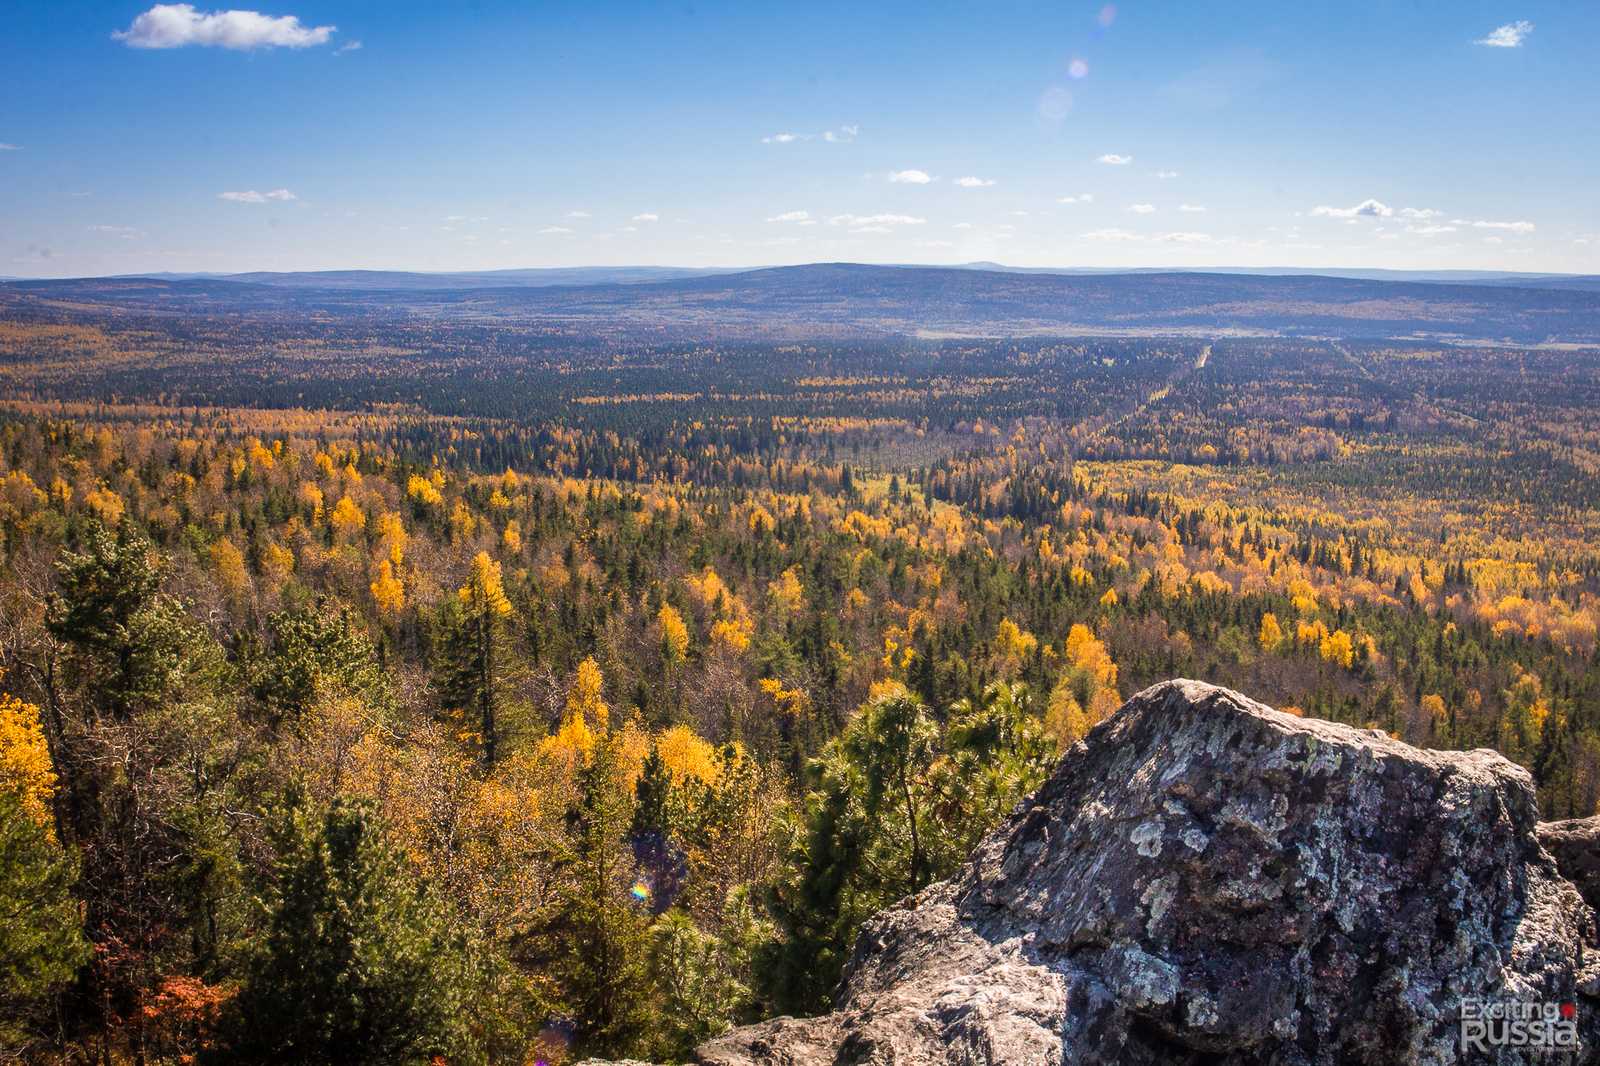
left=0, top=294, right=1600, bottom=1063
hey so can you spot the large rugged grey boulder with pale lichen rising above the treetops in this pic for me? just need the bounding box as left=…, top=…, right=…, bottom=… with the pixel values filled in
left=698, top=680, right=1600, bottom=1066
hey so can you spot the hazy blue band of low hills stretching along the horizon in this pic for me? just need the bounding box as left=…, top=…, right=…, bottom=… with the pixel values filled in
left=9, top=262, right=1600, bottom=344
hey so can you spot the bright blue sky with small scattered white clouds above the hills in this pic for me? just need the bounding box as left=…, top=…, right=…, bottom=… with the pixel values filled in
left=0, top=0, right=1600, bottom=275
